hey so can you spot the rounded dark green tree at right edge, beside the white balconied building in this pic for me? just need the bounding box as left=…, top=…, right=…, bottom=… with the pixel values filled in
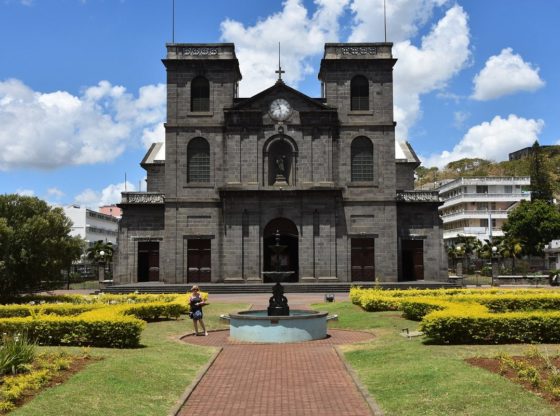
left=502, top=200, right=560, bottom=256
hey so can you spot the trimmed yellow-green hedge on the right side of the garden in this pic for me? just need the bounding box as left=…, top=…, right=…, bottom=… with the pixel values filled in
left=350, top=288, right=560, bottom=344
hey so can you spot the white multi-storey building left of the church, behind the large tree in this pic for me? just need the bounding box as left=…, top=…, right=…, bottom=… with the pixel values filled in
left=64, top=205, right=119, bottom=245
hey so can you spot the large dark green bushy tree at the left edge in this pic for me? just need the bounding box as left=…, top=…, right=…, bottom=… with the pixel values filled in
left=0, top=195, right=83, bottom=299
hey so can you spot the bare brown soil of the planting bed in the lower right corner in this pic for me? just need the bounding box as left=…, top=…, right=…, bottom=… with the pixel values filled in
left=466, top=356, right=560, bottom=411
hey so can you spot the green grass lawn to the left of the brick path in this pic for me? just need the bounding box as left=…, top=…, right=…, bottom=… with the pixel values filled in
left=11, top=303, right=247, bottom=416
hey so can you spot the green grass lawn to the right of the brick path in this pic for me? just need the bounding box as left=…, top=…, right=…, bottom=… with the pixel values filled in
left=314, top=302, right=558, bottom=416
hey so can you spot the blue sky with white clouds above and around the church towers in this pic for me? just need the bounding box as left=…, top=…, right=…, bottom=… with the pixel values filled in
left=0, top=0, right=560, bottom=208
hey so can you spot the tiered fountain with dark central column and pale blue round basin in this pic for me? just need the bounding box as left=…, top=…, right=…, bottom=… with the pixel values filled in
left=222, top=230, right=337, bottom=343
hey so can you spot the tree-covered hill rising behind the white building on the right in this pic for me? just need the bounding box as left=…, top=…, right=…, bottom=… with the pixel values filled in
left=416, top=146, right=560, bottom=199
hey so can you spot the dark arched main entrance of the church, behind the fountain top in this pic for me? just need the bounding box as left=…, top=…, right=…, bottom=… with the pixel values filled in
left=263, top=218, right=299, bottom=283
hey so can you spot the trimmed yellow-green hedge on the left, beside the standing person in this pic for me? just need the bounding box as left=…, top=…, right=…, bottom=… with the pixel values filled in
left=0, top=294, right=195, bottom=348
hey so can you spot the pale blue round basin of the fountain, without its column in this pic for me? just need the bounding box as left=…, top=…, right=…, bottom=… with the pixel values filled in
left=229, top=309, right=328, bottom=344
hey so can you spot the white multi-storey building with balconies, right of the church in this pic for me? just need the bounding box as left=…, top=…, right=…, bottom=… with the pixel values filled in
left=437, top=176, right=531, bottom=245
